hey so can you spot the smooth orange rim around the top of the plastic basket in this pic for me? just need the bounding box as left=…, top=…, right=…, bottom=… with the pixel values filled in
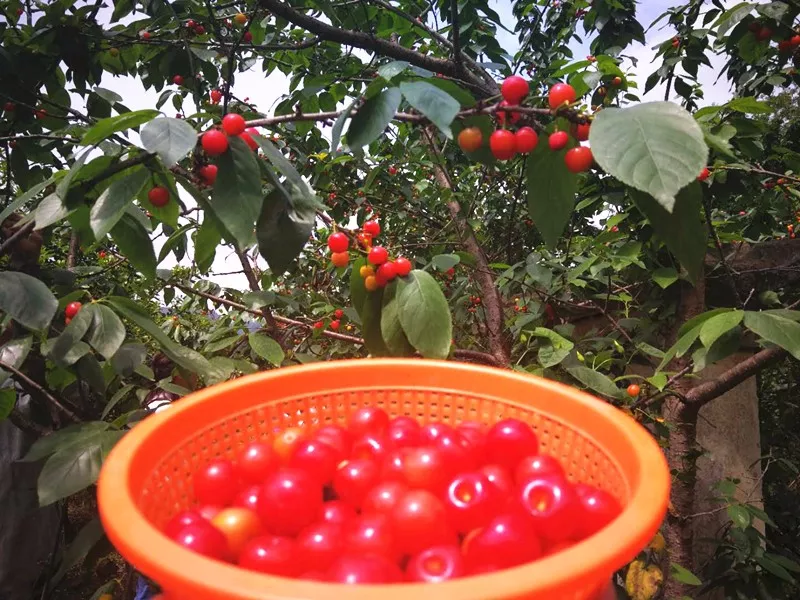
left=98, top=359, right=670, bottom=600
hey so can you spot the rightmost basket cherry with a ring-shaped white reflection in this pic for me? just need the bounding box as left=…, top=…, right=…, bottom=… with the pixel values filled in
left=519, top=475, right=581, bottom=544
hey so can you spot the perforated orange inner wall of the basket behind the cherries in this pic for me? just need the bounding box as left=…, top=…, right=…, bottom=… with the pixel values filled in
left=137, top=386, right=630, bottom=528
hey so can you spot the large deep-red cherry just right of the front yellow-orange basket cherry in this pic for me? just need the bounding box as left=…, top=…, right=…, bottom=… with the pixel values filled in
left=258, top=468, right=322, bottom=535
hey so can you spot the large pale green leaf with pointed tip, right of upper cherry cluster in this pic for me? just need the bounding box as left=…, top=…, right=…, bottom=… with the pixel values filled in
left=589, top=102, right=708, bottom=213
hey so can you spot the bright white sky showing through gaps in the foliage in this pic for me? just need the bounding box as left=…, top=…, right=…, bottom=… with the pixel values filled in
left=81, top=0, right=734, bottom=296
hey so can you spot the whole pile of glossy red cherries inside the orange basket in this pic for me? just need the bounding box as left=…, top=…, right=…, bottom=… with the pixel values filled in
left=164, top=407, right=621, bottom=584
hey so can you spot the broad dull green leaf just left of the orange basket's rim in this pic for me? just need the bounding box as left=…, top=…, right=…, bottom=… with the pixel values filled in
left=37, top=431, right=125, bottom=506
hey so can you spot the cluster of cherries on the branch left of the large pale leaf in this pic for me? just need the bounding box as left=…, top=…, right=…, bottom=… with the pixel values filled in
left=458, top=75, right=594, bottom=173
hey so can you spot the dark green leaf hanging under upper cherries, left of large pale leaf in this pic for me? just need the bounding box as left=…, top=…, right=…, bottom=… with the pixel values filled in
left=525, top=133, right=580, bottom=248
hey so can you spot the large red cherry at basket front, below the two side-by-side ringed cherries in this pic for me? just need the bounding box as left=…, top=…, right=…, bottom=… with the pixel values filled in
left=462, top=512, right=542, bottom=573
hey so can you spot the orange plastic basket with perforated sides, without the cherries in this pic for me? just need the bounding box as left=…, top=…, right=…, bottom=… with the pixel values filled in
left=98, top=359, right=670, bottom=600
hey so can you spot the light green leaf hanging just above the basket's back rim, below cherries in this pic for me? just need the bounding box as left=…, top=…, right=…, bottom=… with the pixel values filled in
left=397, top=269, right=453, bottom=358
